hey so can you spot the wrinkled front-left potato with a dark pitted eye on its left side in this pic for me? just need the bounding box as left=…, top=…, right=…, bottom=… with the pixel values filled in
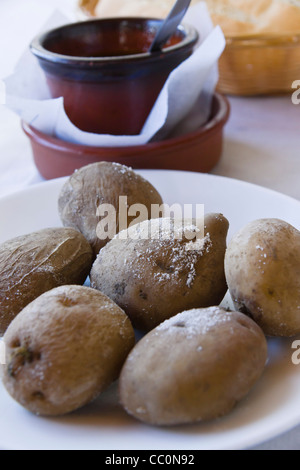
left=2, top=286, right=135, bottom=416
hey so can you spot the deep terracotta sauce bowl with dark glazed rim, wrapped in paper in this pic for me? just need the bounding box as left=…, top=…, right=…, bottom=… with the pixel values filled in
left=30, top=18, right=199, bottom=135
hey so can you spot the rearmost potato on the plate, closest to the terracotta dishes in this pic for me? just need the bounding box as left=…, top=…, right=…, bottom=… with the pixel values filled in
left=58, top=162, right=163, bottom=255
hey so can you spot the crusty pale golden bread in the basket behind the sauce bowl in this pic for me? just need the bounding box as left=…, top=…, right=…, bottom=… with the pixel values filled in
left=86, top=0, right=300, bottom=36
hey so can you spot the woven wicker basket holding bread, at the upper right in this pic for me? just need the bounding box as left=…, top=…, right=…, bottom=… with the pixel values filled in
left=218, top=35, right=300, bottom=96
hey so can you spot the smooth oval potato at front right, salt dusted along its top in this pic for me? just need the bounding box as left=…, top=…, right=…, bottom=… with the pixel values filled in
left=119, top=307, right=267, bottom=426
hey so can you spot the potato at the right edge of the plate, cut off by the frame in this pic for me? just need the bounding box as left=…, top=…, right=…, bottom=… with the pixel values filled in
left=225, top=219, right=300, bottom=337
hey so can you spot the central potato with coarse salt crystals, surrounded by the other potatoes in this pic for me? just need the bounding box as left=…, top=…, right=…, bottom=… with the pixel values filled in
left=90, top=214, right=229, bottom=331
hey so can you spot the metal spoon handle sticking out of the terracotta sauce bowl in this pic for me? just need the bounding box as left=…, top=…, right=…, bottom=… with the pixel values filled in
left=149, top=0, right=191, bottom=52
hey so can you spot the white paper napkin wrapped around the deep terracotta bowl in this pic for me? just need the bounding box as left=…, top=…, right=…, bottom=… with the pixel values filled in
left=5, top=2, right=225, bottom=147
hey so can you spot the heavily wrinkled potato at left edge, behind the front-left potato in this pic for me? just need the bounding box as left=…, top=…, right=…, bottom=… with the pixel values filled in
left=0, top=227, right=93, bottom=335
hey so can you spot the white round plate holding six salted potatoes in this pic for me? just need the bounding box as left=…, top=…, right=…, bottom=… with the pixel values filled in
left=0, top=171, right=300, bottom=450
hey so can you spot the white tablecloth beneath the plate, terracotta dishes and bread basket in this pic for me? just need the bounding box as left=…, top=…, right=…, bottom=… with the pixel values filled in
left=0, top=0, right=300, bottom=450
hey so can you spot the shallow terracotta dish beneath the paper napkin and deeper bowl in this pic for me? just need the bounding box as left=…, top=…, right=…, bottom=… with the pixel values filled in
left=22, top=94, right=230, bottom=179
